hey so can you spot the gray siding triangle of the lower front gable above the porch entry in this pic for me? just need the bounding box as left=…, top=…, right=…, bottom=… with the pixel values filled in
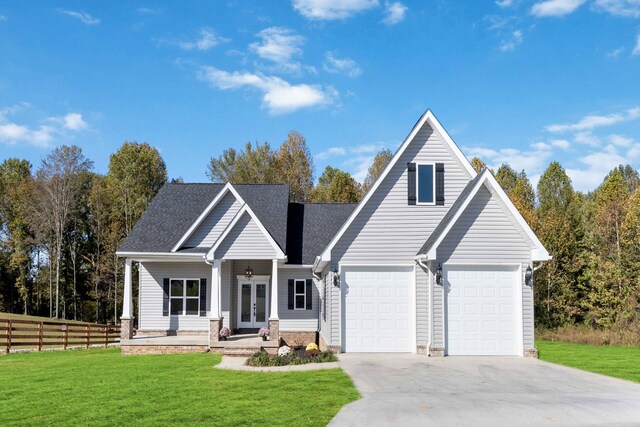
left=215, top=213, right=276, bottom=259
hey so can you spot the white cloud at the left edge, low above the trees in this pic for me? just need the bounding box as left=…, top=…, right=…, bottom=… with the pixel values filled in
left=0, top=103, right=88, bottom=148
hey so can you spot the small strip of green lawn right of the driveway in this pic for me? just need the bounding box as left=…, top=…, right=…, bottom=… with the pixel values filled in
left=536, top=341, right=640, bottom=382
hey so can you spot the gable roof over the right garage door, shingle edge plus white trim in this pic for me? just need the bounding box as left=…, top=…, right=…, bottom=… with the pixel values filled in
left=416, top=169, right=551, bottom=261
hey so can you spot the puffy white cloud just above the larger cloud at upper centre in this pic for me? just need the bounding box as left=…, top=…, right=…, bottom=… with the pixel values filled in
left=249, top=27, right=306, bottom=72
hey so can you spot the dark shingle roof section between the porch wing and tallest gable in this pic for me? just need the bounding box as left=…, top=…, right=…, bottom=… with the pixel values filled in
left=287, top=203, right=357, bottom=264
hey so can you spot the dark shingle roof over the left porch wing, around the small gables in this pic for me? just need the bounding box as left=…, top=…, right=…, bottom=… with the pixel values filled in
left=118, top=183, right=289, bottom=253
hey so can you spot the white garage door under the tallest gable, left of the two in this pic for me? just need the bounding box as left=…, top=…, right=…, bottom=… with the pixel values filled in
left=341, top=267, right=414, bottom=352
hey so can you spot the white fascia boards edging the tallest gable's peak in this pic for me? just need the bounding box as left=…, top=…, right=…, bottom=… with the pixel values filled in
left=320, top=109, right=477, bottom=261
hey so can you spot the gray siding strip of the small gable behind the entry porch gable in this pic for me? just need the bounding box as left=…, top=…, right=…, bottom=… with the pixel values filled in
left=183, top=192, right=241, bottom=248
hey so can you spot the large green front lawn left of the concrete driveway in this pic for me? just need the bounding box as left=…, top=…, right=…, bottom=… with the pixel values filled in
left=0, top=349, right=359, bottom=426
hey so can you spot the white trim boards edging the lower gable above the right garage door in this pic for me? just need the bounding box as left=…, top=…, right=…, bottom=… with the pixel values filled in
left=417, top=169, right=551, bottom=261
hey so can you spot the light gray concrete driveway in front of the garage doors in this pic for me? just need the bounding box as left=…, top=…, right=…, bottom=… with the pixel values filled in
left=329, top=354, right=640, bottom=427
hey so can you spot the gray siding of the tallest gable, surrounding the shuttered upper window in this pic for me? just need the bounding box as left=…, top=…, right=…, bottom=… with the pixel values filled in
left=331, top=124, right=471, bottom=269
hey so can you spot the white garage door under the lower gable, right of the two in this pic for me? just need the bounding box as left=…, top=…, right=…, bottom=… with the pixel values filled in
left=445, top=266, right=522, bottom=356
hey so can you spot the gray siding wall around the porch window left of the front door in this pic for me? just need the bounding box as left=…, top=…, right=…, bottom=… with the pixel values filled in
left=138, top=262, right=211, bottom=331
